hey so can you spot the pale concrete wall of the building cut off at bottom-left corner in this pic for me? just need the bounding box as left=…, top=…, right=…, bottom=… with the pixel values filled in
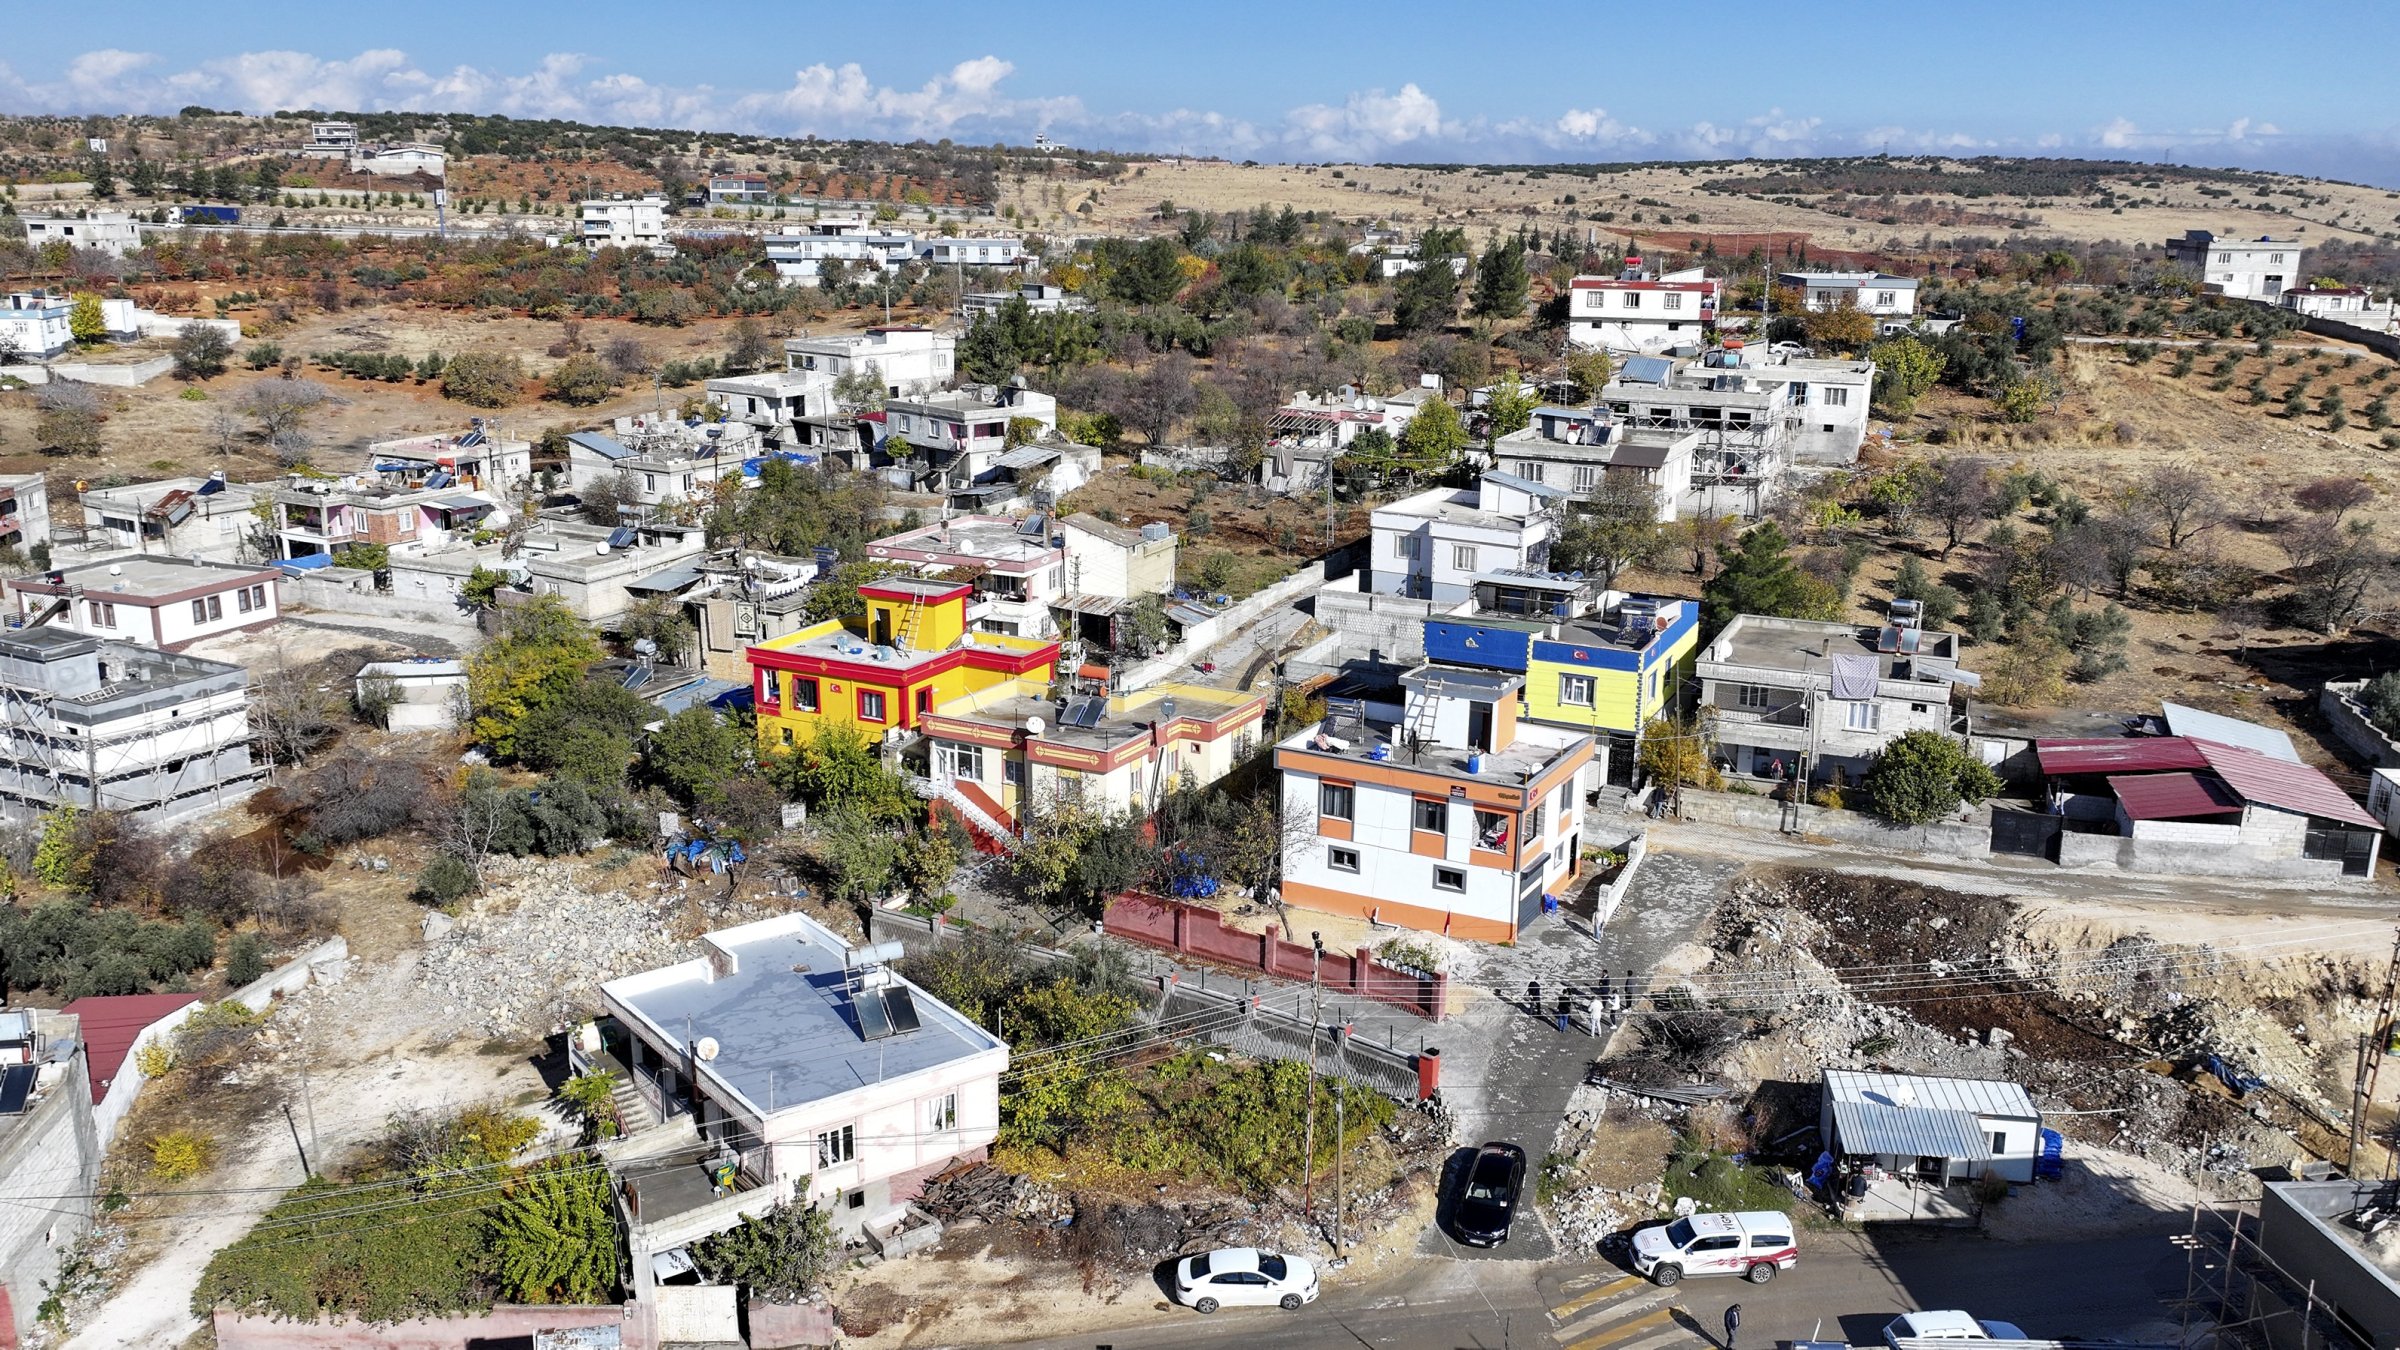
left=0, top=1052, right=101, bottom=1345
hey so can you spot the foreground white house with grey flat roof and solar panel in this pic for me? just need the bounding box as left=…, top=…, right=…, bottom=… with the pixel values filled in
left=595, top=913, right=1008, bottom=1283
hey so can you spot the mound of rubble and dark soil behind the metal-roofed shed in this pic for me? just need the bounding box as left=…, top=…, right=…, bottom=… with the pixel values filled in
left=1709, top=870, right=2345, bottom=1177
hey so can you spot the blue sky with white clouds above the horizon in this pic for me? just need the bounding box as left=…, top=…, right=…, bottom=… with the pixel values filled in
left=14, top=0, right=2400, bottom=185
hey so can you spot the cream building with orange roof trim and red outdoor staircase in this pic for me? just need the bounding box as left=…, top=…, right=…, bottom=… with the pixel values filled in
left=922, top=665, right=1267, bottom=846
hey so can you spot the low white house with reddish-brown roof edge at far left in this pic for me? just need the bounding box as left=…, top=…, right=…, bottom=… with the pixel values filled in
left=7, top=557, right=283, bottom=651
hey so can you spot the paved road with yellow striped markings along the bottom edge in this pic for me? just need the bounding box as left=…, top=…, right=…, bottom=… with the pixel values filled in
left=998, top=1215, right=2184, bottom=1350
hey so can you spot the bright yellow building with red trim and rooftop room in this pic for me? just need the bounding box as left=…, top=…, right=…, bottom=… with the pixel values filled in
left=749, top=577, right=1058, bottom=752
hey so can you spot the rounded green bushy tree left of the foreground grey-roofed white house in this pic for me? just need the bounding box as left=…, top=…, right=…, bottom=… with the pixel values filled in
left=492, top=1155, right=617, bottom=1304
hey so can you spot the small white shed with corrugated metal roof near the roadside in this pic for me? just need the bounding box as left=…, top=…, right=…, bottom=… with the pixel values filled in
left=1817, top=1069, right=2042, bottom=1184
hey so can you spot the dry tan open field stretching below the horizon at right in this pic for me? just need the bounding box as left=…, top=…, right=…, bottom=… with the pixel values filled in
left=1001, top=159, right=2400, bottom=257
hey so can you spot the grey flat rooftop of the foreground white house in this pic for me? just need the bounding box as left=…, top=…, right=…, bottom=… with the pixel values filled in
left=600, top=915, right=1008, bottom=1115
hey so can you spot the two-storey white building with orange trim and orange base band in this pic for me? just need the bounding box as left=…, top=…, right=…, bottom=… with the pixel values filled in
left=1274, top=665, right=1598, bottom=942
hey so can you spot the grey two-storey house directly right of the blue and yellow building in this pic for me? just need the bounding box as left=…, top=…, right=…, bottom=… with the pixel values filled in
left=1692, top=615, right=1975, bottom=785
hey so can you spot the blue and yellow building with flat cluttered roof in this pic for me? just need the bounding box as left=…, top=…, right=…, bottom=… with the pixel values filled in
left=1426, top=574, right=1699, bottom=785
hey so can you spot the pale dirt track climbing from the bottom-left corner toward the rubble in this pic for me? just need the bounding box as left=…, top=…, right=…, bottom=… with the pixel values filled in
left=65, top=951, right=545, bottom=1350
